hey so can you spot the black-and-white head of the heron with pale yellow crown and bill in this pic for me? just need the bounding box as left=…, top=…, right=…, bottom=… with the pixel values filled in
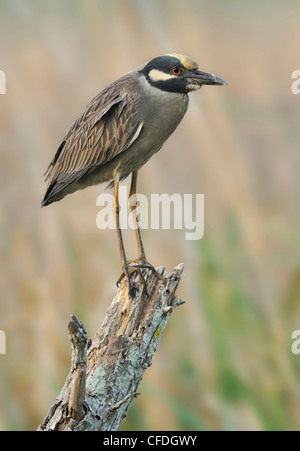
left=140, top=53, right=228, bottom=94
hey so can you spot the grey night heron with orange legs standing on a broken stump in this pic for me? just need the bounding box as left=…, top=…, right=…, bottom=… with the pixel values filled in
left=42, top=53, right=228, bottom=298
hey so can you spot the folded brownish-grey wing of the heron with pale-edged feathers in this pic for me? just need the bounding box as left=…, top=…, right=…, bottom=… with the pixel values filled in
left=42, top=84, right=142, bottom=205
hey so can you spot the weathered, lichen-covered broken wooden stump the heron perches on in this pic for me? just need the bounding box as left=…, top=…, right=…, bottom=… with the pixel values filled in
left=38, top=264, right=184, bottom=431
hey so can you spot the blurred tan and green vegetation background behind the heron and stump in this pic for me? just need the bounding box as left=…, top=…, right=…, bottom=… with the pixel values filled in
left=0, top=0, right=300, bottom=430
